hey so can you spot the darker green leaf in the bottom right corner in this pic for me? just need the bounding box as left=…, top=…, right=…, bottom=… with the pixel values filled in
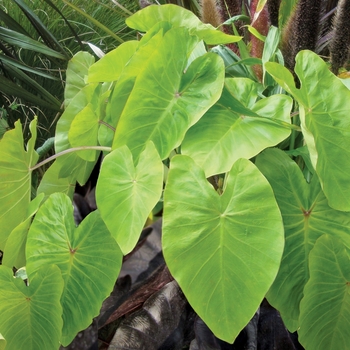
left=298, top=234, right=350, bottom=350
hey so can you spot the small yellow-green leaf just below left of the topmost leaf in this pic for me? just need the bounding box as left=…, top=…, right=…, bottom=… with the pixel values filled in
left=88, top=40, right=139, bottom=83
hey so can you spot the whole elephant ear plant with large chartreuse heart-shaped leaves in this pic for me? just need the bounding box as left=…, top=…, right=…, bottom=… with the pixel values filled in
left=0, top=5, right=350, bottom=350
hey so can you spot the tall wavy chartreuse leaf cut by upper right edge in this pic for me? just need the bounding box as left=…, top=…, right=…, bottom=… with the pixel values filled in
left=266, top=51, right=350, bottom=211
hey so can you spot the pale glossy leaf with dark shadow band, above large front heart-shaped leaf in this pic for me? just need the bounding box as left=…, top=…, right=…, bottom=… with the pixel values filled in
left=181, top=78, right=292, bottom=177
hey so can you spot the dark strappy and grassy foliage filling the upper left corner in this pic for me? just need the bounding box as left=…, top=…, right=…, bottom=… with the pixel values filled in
left=0, top=0, right=139, bottom=143
